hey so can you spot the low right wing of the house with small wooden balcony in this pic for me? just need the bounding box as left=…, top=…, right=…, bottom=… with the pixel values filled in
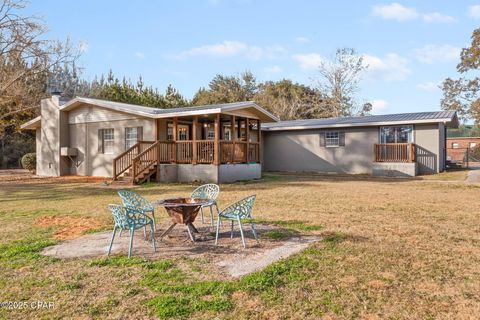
left=262, top=111, right=458, bottom=176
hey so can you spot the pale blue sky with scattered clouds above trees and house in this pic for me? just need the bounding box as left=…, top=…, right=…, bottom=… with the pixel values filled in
left=26, top=0, right=480, bottom=114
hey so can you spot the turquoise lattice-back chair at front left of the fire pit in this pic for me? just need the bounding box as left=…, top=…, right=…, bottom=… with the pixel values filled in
left=107, top=204, right=157, bottom=258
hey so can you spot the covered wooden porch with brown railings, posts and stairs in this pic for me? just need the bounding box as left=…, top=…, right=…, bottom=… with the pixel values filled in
left=113, top=113, right=261, bottom=183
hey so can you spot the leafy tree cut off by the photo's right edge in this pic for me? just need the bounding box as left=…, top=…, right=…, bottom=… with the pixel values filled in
left=440, top=28, right=480, bottom=123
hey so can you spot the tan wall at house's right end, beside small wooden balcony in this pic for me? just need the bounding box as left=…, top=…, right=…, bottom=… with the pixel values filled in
left=414, top=123, right=443, bottom=174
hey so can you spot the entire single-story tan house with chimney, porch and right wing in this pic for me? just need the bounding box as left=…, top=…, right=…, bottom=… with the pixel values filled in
left=22, top=95, right=458, bottom=183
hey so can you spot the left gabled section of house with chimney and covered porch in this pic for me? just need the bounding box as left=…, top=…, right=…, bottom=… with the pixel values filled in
left=22, top=95, right=278, bottom=183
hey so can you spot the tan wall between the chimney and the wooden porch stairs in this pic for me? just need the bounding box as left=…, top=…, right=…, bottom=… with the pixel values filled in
left=69, top=119, right=155, bottom=177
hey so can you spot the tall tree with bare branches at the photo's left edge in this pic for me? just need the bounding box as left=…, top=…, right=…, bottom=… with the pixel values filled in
left=0, top=0, right=79, bottom=167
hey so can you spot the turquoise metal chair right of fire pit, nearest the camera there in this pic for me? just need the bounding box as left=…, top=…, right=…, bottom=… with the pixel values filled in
left=215, top=195, right=258, bottom=248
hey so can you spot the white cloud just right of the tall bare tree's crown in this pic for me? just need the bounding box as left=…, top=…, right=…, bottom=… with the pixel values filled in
left=363, top=53, right=412, bottom=81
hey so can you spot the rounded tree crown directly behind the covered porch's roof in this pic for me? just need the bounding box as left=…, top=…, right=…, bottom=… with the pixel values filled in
left=192, top=71, right=258, bottom=106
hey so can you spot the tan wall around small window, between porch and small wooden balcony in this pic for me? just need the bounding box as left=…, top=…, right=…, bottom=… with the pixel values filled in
left=262, top=128, right=378, bottom=174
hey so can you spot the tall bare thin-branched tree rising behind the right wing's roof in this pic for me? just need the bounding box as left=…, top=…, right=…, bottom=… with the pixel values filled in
left=317, top=48, right=371, bottom=117
